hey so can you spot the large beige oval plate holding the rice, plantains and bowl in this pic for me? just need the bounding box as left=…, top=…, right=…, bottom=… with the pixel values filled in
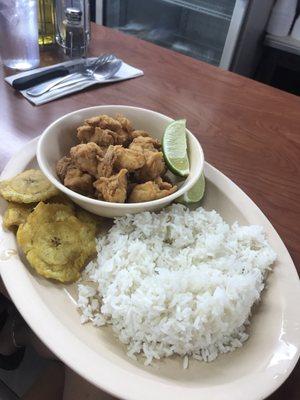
left=0, top=140, right=300, bottom=400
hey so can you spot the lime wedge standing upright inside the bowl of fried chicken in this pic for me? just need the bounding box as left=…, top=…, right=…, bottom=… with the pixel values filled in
left=162, top=119, right=190, bottom=176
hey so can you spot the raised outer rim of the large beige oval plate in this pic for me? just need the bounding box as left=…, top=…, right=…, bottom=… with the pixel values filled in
left=0, top=137, right=300, bottom=400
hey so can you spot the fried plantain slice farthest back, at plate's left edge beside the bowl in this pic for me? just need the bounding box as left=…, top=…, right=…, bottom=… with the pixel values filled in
left=0, top=169, right=58, bottom=203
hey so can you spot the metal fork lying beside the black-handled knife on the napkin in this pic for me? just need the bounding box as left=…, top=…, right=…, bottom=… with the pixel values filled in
left=26, top=54, right=118, bottom=97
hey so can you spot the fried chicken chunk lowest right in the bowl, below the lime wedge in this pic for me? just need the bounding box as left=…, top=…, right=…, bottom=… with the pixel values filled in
left=128, top=178, right=177, bottom=203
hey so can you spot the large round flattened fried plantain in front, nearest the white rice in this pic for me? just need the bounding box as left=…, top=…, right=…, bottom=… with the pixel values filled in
left=17, top=202, right=96, bottom=282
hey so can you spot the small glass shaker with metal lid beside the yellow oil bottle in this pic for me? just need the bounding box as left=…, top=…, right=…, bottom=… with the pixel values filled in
left=63, top=7, right=87, bottom=58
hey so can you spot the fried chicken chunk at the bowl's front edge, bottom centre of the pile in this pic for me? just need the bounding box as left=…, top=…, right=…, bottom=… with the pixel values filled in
left=94, top=169, right=128, bottom=203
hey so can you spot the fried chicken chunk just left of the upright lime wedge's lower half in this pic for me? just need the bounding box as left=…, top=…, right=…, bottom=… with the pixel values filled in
left=134, top=151, right=166, bottom=182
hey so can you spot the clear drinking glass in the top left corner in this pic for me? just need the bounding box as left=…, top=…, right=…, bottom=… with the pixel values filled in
left=0, top=0, right=40, bottom=70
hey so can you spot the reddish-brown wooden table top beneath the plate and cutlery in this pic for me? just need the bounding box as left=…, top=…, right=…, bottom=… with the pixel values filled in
left=0, top=26, right=300, bottom=400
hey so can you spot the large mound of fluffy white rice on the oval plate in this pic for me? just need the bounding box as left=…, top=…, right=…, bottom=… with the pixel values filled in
left=78, top=204, right=276, bottom=367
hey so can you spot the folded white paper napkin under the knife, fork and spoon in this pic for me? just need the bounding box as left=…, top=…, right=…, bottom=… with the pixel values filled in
left=5, top=58, right=144, bottom=106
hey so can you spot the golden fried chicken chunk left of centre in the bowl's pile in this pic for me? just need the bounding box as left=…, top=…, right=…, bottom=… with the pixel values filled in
left=70, top=142, right=104, bottom=177
